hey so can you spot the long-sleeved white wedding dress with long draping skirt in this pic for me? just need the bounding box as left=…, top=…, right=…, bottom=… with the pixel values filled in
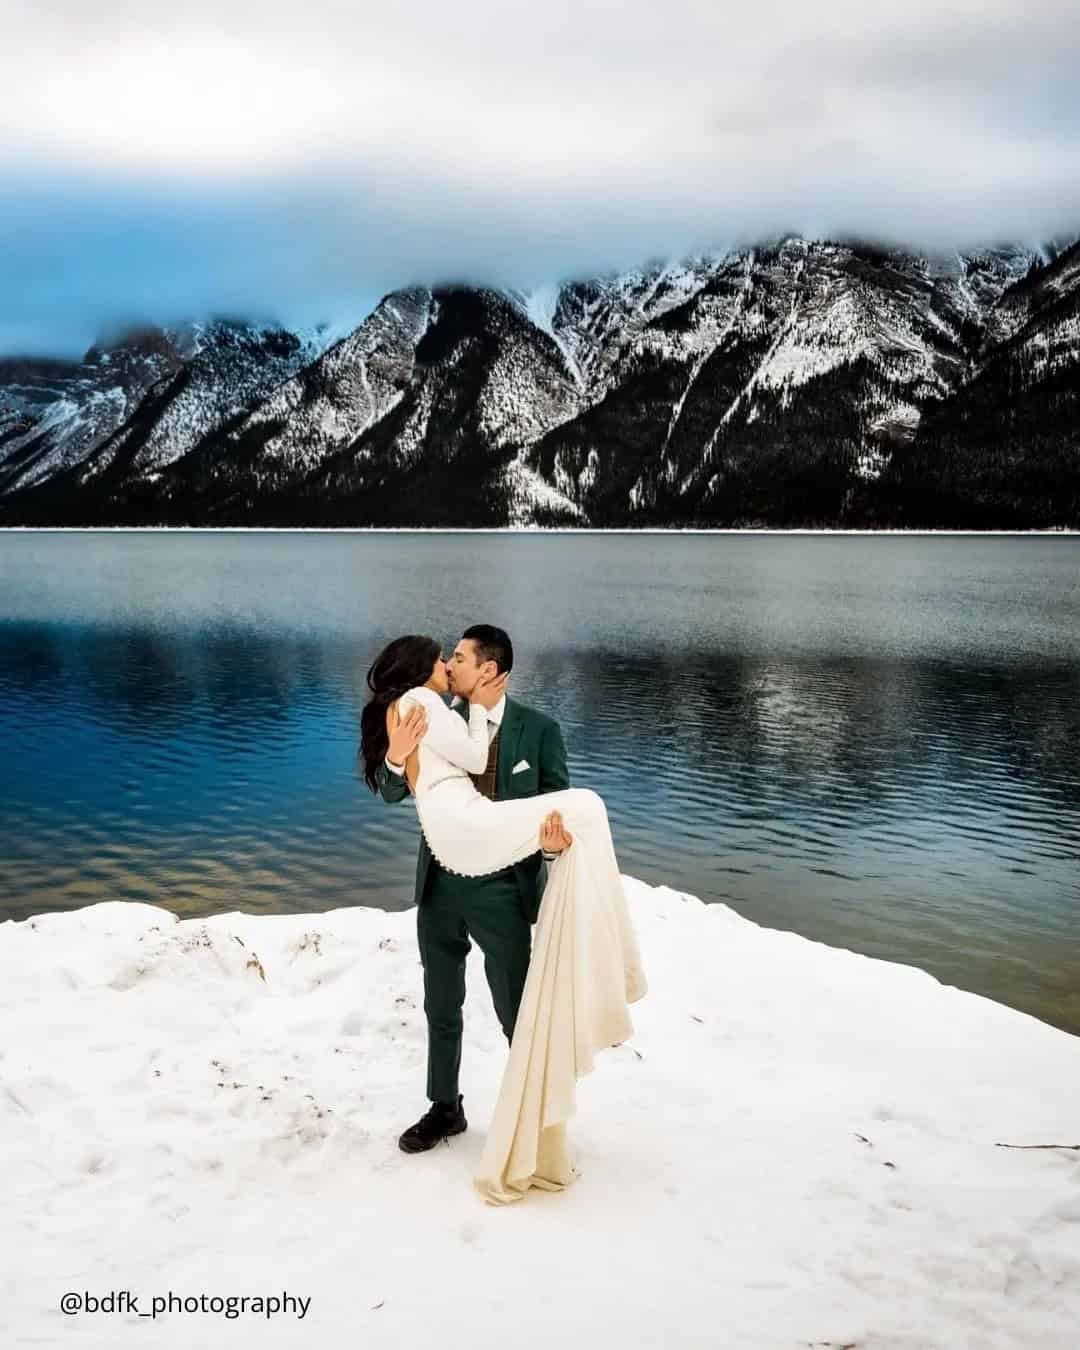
left=398, top=687, right=648, bottom=1204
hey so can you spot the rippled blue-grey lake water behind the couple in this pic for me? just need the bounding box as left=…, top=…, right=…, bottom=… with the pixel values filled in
left=0, top=531, right=1080, bottom=1033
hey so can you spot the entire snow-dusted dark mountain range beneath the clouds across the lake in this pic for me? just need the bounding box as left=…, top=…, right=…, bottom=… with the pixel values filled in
left=0, top=236, right=1080, bottom=528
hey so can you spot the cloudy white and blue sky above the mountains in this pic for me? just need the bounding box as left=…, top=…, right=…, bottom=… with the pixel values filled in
left=0, top=0, right=1080, bottom=356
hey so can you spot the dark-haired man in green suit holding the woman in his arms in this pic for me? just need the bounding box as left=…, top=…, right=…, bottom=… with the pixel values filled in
left=375, top=624, right=570, bottom=1153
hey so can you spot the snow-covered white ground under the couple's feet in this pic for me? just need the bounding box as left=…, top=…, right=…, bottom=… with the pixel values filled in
left=0, top=878, right=1080, bottom=1350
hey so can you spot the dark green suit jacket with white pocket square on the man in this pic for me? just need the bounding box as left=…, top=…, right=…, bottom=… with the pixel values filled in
left=375, top=697, right=570, bottom=923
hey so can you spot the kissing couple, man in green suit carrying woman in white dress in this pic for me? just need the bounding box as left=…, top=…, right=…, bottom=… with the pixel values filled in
left=360, top=624, right=647, bottom=1204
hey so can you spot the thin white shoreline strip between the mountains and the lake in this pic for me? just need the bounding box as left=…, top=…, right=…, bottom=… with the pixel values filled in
left=0, top=525, right=1080, bottom=539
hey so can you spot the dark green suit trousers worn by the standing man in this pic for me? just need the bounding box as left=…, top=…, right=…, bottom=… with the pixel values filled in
left=416, top=859, right=532, bottom=1106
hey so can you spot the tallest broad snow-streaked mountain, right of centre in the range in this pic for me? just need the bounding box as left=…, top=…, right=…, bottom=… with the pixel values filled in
left=518, top=238, right=1080, bottom=525
